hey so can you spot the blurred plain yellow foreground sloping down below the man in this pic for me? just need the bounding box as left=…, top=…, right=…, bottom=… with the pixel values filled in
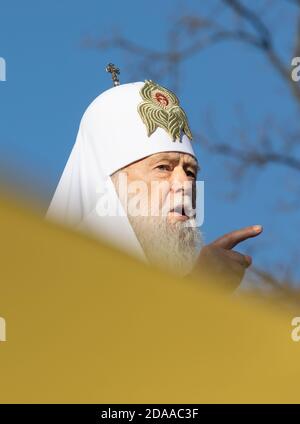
left=0, top=194, right=300, bottom=403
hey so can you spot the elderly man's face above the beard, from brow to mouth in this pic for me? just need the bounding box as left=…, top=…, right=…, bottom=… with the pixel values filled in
left=115, top=152, right=198, bottom=224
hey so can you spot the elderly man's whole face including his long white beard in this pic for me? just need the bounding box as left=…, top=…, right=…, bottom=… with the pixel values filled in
left=112, top=152, right=202, bottom=275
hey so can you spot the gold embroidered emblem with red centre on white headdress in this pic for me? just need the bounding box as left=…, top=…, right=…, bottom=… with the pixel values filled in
left=138, top=80, right=192, bottom=141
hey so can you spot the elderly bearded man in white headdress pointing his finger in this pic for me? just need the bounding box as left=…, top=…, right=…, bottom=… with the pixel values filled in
left=48, top=81, right=262, bottom=287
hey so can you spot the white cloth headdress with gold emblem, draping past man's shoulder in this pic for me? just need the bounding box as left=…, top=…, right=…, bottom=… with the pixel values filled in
left=47, top=81, right=195, bottom=258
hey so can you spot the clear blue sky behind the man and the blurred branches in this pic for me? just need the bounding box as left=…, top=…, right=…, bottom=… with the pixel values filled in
left=0, top=0, right=300, bottom=282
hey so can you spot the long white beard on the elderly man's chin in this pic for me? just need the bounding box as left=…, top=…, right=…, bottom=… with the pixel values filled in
left=129, top=216, right=203, bottom=276
